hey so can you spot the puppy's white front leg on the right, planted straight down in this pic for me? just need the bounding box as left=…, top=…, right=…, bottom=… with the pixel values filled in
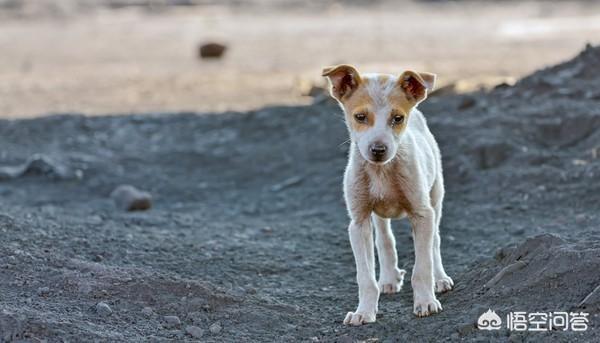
left=410, top=208, right=442, bottom=317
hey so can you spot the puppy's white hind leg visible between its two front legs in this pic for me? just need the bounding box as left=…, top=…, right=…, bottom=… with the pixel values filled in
left=372, top=213, right=406, bottom=293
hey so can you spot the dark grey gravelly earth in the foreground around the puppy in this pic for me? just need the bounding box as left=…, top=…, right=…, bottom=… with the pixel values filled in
left=0, top=47, right=600, bottom=342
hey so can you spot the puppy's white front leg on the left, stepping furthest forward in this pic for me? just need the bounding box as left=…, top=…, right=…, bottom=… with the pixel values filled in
left=344, top=217, right=379, bottom=325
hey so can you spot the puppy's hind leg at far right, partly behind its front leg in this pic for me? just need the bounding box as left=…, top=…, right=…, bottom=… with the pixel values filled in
left=431, top=173, right=454, bottom=293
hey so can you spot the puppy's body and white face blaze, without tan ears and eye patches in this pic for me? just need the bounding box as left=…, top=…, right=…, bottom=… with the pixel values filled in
left=342, top=74, right=453, bottom=325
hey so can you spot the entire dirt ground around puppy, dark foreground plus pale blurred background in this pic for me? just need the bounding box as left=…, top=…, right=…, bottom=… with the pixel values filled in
left=0, top=1, right=600, bottom=342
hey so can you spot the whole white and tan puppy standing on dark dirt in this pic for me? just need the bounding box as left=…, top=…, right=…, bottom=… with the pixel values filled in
left=323, top=65, right=453, bottom=325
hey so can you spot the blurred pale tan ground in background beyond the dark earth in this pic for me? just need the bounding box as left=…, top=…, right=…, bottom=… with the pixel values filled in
left=0, top=0, right=600, bottom=118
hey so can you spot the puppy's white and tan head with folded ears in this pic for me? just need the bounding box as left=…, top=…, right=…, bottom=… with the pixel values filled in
left=323, top=64, right=435, bottom=164
